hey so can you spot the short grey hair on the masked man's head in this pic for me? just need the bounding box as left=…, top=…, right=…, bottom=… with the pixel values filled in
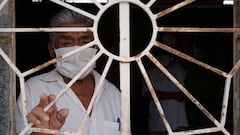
left=49, top=9, right=93, bottom=43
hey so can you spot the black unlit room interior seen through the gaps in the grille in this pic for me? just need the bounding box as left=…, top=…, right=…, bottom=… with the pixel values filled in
left=16, top=0, right=233, bottom=135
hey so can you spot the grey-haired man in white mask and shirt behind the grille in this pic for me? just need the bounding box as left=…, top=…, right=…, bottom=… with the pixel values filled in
left=16, top=9, right=120, bottom=135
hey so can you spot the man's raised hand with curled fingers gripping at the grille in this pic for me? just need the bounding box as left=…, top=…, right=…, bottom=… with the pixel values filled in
left=27, top=93, right=69, bottom=135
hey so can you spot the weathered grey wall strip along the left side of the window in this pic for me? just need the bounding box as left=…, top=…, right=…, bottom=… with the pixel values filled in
left=0, top=0, right=16, bottom=135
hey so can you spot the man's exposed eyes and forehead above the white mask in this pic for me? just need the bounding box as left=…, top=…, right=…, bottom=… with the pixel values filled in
left=55, top=24, right=93, bottom=48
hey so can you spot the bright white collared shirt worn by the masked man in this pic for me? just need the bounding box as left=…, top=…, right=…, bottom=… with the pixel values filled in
left=16, top=70, right=120, bottom=135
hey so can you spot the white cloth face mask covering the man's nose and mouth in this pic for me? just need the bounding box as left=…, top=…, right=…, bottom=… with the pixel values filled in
left=54, top=46, right=97, bottom=80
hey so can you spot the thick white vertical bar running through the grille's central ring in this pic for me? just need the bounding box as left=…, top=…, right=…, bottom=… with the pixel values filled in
left=119, top=2, right=131, bottom=135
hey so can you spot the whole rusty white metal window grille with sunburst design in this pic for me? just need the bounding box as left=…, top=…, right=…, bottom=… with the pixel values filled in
left=0, top=0, right=240, bottom=135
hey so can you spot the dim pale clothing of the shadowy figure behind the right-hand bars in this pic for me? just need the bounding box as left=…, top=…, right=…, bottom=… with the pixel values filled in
left=143, top=62, right=188, bottom=132
